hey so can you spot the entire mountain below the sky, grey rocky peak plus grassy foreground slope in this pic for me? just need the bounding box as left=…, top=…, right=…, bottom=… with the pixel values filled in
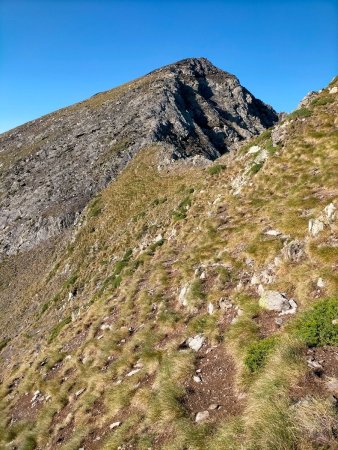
left=0, top=58, right=338, bottom=450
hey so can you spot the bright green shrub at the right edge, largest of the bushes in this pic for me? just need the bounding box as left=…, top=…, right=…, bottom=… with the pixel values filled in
left=294, top=298, right=338, bottom=347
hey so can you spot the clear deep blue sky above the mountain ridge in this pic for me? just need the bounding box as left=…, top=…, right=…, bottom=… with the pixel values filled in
left=0, top=0, right=338, bottom=132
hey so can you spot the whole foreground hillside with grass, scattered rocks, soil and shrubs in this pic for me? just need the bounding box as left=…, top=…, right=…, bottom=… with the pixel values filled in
left=0, top=72, right=338, bottom=450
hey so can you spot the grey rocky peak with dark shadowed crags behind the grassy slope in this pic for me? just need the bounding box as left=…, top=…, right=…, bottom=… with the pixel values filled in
left=0, top=58, right=278, bottom=256
